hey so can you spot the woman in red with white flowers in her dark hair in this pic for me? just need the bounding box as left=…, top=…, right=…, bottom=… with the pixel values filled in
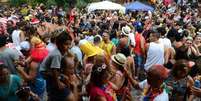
left=87, top=60, right=115, bottom=101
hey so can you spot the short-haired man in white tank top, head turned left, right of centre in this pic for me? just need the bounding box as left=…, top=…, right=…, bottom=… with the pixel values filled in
left=144, top=29, right=166, bottom=71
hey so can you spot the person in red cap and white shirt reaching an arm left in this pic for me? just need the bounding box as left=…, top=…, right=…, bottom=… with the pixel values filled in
left=124, top=64, right=170, bottom=101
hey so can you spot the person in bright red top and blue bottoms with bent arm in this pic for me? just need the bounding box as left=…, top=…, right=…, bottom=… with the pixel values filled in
left=17, top=36, right=48, bottom=100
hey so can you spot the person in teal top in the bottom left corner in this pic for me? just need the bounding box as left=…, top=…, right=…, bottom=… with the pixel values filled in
left=0, top=63, right=22, bottom=101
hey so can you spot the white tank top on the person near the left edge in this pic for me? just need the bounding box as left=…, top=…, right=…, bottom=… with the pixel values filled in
left=12, top=30, right=21, bottom=46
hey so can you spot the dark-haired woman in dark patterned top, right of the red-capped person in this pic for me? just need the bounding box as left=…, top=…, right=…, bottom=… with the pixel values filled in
left=166, top=59, right=193, bottom=101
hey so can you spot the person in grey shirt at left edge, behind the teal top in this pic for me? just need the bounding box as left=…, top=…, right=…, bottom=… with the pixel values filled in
left=0, top=35, right=19, bottom=74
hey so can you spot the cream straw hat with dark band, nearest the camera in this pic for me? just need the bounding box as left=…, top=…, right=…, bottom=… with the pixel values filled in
left=112, top=53, right=126, bottom=66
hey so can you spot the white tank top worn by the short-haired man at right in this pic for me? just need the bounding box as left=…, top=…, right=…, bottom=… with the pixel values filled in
left=145, top=42, right=164, bottom=71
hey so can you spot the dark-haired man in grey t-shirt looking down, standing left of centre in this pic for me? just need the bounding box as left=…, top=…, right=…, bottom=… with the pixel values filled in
left=40, top=31, right=72, bottom=101
